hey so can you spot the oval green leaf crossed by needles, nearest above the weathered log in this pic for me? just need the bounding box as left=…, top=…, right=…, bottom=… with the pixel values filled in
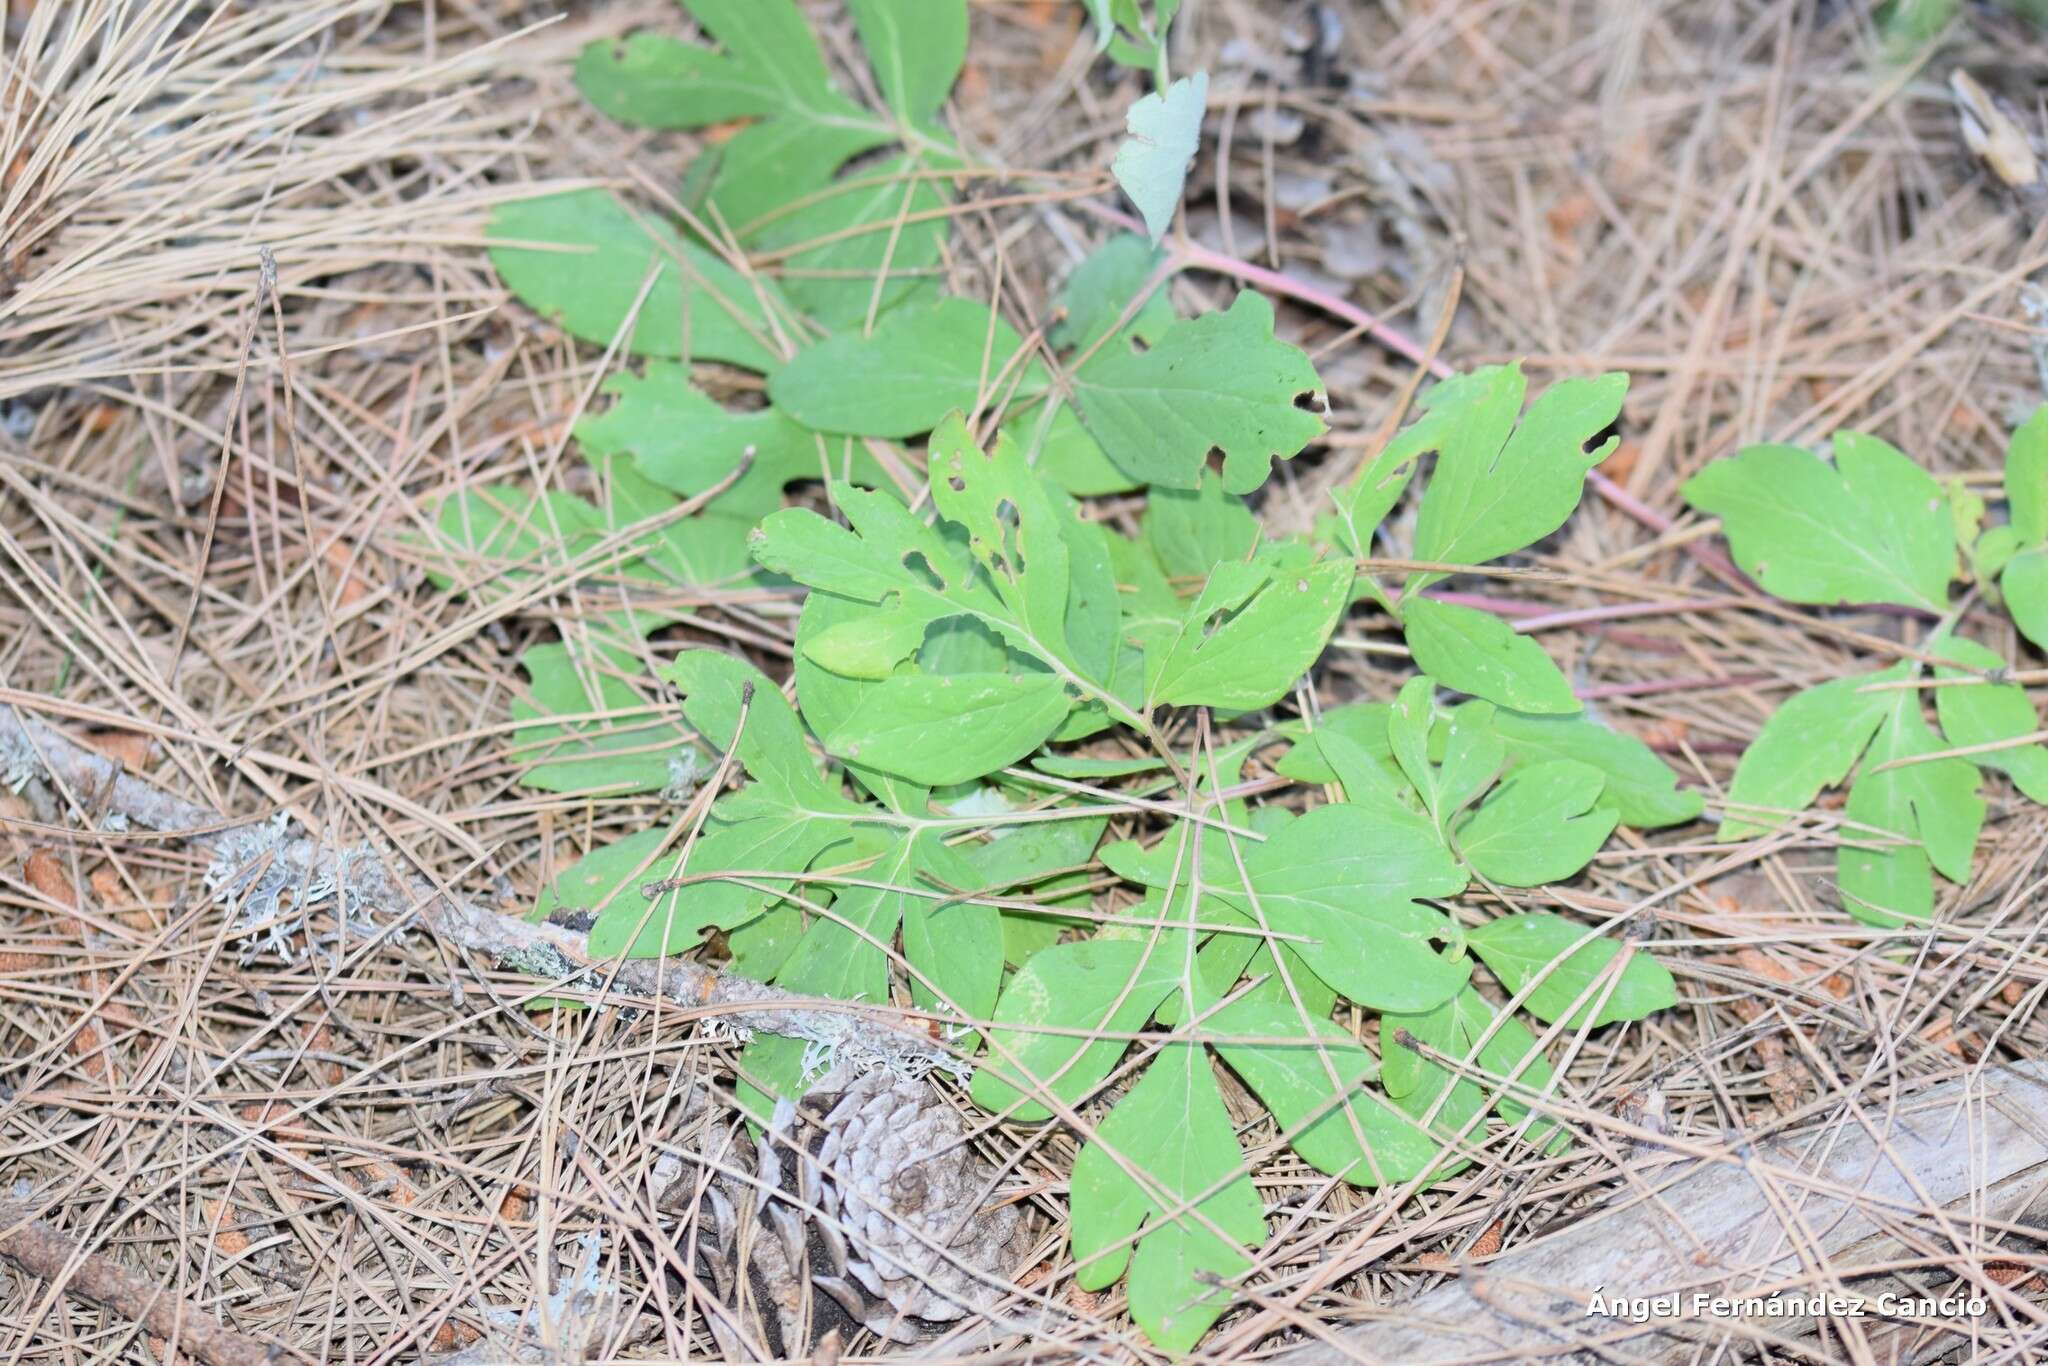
left=1466, top=911, right=1677, bottom=1030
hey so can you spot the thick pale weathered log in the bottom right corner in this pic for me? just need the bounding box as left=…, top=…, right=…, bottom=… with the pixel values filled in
left=1274, top=1061, right=2048, bottom=1366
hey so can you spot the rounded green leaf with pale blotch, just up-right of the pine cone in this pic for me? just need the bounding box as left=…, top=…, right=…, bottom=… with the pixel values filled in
left=973, top=940, right=1182, bottom=1122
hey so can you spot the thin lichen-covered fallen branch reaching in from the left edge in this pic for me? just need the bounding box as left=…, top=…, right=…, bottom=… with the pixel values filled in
left=0, top=702, right=958, bottom=1075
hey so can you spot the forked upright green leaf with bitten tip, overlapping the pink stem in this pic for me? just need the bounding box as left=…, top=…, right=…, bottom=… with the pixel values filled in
left=1409, top=365, right=1628, bottom=585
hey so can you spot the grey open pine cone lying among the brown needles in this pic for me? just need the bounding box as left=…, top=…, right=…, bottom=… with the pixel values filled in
left=662, top=1069, right=1032, bottom=1360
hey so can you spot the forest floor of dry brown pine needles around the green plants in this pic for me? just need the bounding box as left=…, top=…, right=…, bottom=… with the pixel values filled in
left=0, top=0, right=2048, bottom=1362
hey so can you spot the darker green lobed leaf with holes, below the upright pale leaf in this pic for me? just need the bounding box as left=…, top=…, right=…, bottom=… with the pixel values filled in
left=1071, top=291, right=1327, bottom=494
